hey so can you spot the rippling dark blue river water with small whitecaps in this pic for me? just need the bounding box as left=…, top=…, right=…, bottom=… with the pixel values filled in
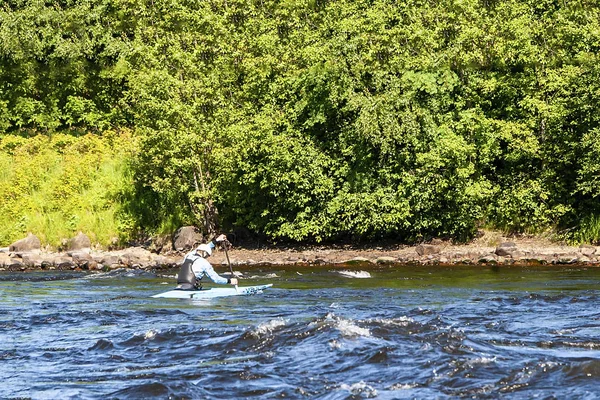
left=0, top=267, right=600, bottom=399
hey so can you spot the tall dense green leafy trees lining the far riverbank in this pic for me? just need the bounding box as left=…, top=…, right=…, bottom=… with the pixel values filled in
left=0, top=0, right=600, bottom=245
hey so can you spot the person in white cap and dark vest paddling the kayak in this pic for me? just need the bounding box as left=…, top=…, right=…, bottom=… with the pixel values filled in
left=177, top=234, right=237, bottom=290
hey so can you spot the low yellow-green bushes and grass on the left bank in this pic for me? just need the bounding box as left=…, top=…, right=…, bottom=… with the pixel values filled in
left=0, top=132, right=135, bottom=248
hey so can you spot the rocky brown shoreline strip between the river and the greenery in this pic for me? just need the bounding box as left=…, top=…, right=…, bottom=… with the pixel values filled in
left=0, top=230, right=600, bottom=271
